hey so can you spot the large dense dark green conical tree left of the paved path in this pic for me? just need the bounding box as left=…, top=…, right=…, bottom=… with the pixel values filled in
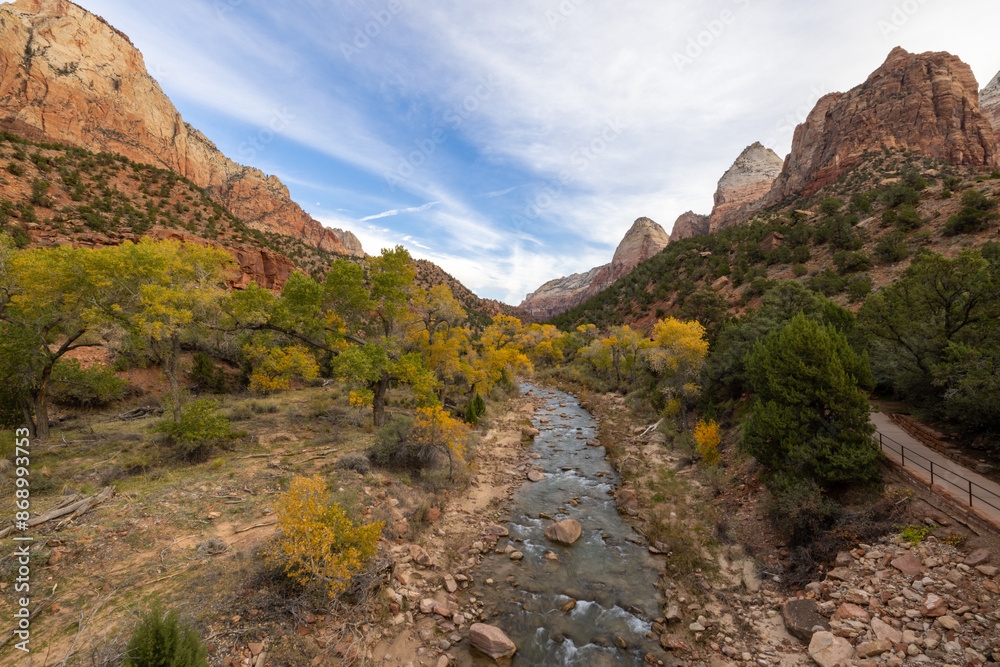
left=742, top=313, right=879, bottom=487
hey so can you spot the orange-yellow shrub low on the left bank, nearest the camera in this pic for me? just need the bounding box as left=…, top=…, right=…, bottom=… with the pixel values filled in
left=264, top=477, right=385, bottom=597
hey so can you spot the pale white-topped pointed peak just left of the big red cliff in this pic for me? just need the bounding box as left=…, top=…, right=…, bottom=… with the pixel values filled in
left=709, top=141, right=784, bottom=231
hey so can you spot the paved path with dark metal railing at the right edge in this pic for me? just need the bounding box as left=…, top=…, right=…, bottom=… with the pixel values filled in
left=871, top=412, right=1000, bottom=528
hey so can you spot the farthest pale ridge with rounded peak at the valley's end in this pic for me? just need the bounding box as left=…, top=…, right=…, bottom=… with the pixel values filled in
left=519, top=218, right=670, bottom=320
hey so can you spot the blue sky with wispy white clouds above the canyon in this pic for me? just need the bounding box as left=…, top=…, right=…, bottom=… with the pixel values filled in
left=80, top=0, right=1000, bottom=304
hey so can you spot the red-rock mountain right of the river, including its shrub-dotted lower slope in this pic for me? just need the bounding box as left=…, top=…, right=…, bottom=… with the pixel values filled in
left=553, top=47, right=1000, bottom=327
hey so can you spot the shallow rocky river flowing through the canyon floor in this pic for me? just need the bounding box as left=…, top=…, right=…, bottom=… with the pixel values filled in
left=464, top=385, right=662, bottom=667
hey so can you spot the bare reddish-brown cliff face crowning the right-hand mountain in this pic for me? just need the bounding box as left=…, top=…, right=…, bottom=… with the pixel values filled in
left=763, top=47, right=998, bottom=205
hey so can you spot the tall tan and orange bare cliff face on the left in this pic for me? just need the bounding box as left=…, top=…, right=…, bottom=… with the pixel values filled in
left=0, top=0, right=363, bottom=256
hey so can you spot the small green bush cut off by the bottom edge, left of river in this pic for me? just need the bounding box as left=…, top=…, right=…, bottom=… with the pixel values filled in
left=124, top=607, right=208, bottom=667
